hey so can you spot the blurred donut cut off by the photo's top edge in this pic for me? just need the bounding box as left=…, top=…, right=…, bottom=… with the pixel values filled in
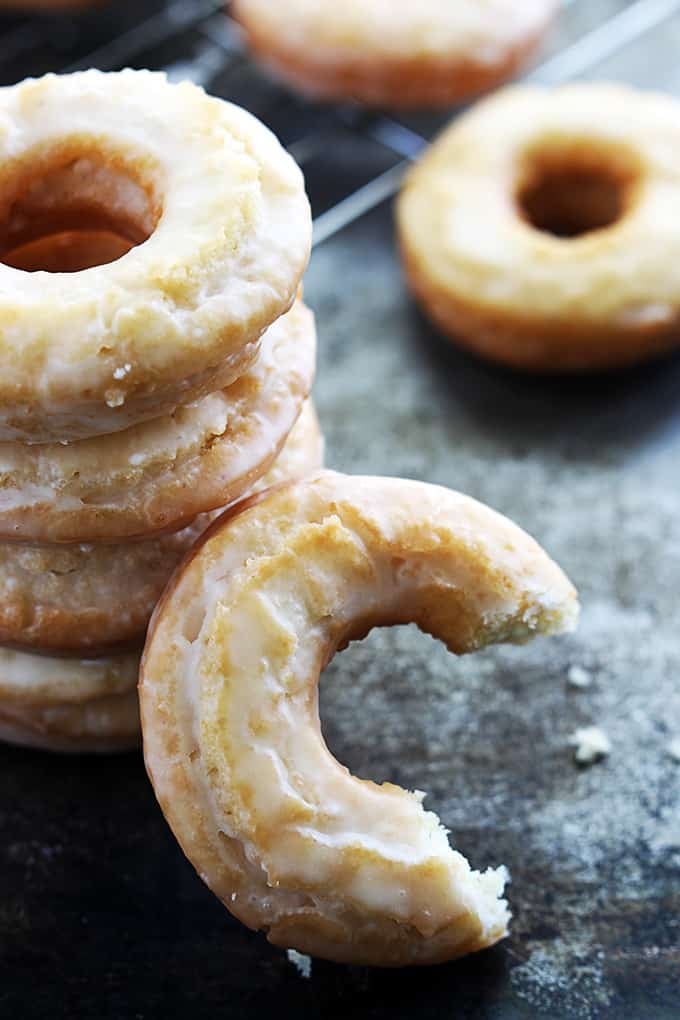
left=230, top=0, right=557, bottom=108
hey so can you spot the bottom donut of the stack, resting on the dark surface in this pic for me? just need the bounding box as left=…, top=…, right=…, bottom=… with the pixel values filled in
left=0, top=648, right=140, bottom=752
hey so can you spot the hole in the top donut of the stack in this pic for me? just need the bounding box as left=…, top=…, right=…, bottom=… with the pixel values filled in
left=0, top=143, right=162, bottom=272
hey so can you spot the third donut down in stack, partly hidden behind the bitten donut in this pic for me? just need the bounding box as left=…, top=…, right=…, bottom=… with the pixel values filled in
left=0, top=401, right=323, bottom=656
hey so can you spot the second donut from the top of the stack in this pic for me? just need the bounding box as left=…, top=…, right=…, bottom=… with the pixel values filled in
left=0, top=302, right=316, bottom=544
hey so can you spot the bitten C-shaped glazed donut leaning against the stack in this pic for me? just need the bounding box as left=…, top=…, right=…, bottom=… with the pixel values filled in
left=140, top=472, right=577, bottom=966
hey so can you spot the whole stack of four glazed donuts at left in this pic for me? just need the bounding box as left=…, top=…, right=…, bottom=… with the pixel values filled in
left=0, top=71, right=322, bottom=751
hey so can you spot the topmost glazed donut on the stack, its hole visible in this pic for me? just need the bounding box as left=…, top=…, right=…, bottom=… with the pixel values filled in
left=0, top=70, right=311, bottom=443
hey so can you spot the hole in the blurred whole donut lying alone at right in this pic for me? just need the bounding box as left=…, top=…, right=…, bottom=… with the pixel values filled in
left=516, top=148, right=639, bottom=239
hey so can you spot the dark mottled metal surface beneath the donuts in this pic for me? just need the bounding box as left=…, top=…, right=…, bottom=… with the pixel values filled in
left=0, top=0, right=680, bottom=1020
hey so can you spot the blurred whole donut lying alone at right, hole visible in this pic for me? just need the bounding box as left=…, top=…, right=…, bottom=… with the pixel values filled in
left=398, top=84, right=680, bottom=372
